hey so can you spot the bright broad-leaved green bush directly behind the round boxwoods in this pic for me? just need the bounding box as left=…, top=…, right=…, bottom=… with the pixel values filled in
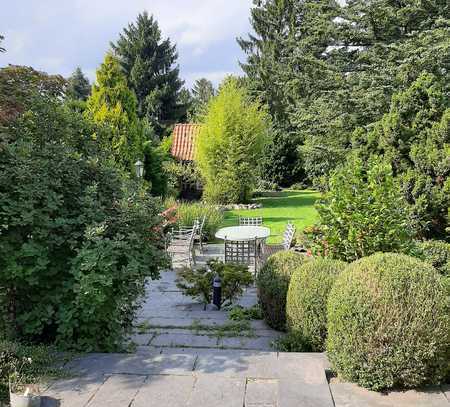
left=316, top=157, right=414, bottom=261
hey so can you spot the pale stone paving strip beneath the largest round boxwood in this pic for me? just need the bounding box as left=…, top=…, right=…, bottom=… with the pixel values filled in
left=330, top=379, right=450, bottom=407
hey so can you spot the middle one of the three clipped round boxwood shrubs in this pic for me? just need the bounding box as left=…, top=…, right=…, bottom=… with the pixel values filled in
left=286, top=258, right=347, bottom=352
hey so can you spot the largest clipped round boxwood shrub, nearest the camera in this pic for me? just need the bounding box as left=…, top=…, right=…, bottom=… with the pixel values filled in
left=327, top=253, right=450, bottom=390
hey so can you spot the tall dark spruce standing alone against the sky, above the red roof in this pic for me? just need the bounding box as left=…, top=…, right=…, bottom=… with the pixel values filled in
left=111, top=12, right=185, bottom=136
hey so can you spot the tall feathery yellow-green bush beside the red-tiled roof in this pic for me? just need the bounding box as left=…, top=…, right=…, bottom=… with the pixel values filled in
left=196, top=78, right=270, bottom=204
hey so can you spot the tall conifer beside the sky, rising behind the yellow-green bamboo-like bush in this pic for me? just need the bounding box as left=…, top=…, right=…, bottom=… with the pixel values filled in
left=238, top=0, right=338, bottom=185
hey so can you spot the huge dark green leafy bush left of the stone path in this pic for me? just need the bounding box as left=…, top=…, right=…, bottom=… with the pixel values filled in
left=0, top=96, right=165, bottom=351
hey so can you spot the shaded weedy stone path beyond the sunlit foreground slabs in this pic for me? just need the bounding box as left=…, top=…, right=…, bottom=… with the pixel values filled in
left=131, top=245, right=280, bottom=351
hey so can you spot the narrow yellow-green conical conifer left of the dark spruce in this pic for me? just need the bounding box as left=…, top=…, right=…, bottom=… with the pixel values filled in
left=86, top=53, right=144, bottom=171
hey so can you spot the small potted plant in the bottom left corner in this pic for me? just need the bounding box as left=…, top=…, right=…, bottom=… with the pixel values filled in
left=9, top=358, right=41, bottom=407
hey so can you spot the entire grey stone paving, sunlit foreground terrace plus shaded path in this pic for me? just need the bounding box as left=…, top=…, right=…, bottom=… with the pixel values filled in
left=42, top=246, right=450, bottom=407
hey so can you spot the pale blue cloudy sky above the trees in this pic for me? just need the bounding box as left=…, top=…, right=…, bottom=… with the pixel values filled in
left=0, top=0, right=252, bottom=87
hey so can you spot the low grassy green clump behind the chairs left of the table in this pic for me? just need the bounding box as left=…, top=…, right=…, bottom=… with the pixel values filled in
left=176, top=202, right=223, bottom=240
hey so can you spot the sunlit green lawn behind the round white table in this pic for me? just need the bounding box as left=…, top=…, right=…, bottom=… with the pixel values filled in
left=221, top=190, right=320, bottom=243
